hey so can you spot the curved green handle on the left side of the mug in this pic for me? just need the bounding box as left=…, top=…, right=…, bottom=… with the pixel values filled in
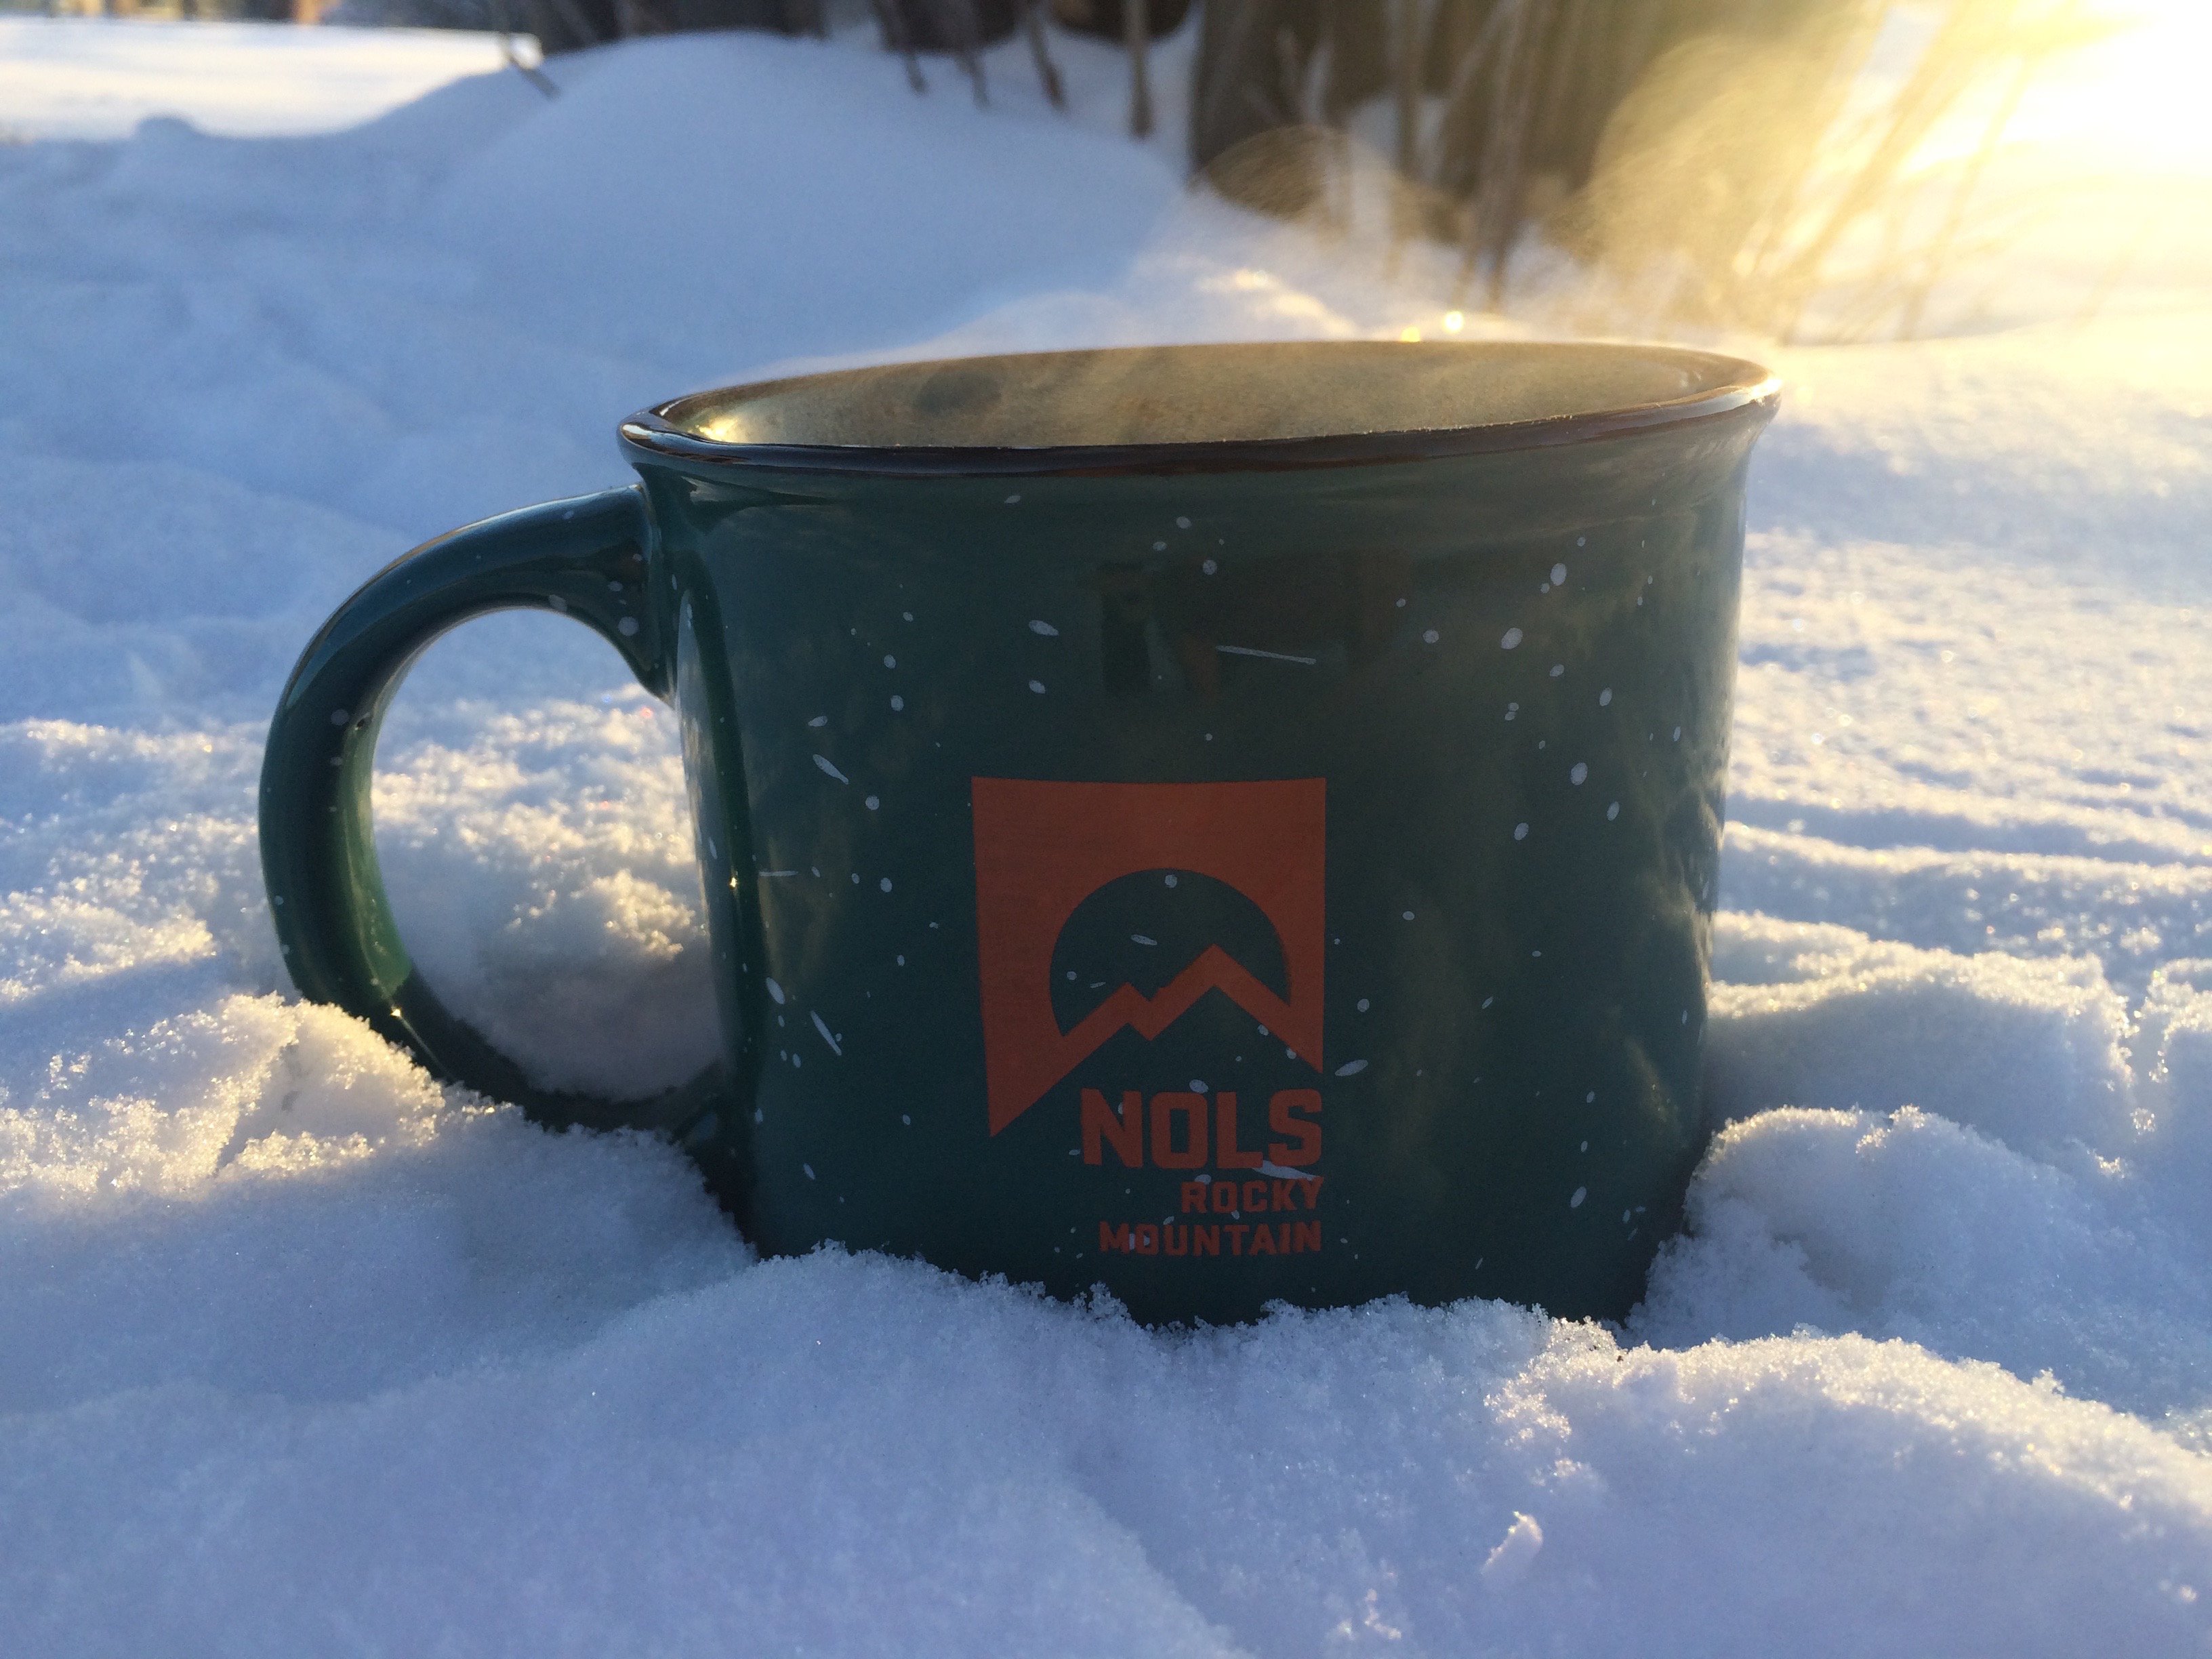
left=261, top=473, right=717, bottom=1130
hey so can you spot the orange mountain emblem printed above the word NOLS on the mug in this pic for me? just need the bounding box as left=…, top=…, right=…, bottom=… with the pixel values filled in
left=973, top=779, right=1327, bottom=1134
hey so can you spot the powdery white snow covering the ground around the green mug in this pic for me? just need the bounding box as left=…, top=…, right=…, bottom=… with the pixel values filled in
left=0, top=20, right=2212, bottom=1654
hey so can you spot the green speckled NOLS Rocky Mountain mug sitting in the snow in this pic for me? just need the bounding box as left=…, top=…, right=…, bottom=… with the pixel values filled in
left=261, top=343, right=1778, bottom=1323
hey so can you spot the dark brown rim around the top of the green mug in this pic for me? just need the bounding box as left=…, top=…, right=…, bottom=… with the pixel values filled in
left=617, top=341, right=1783, bottom=478
